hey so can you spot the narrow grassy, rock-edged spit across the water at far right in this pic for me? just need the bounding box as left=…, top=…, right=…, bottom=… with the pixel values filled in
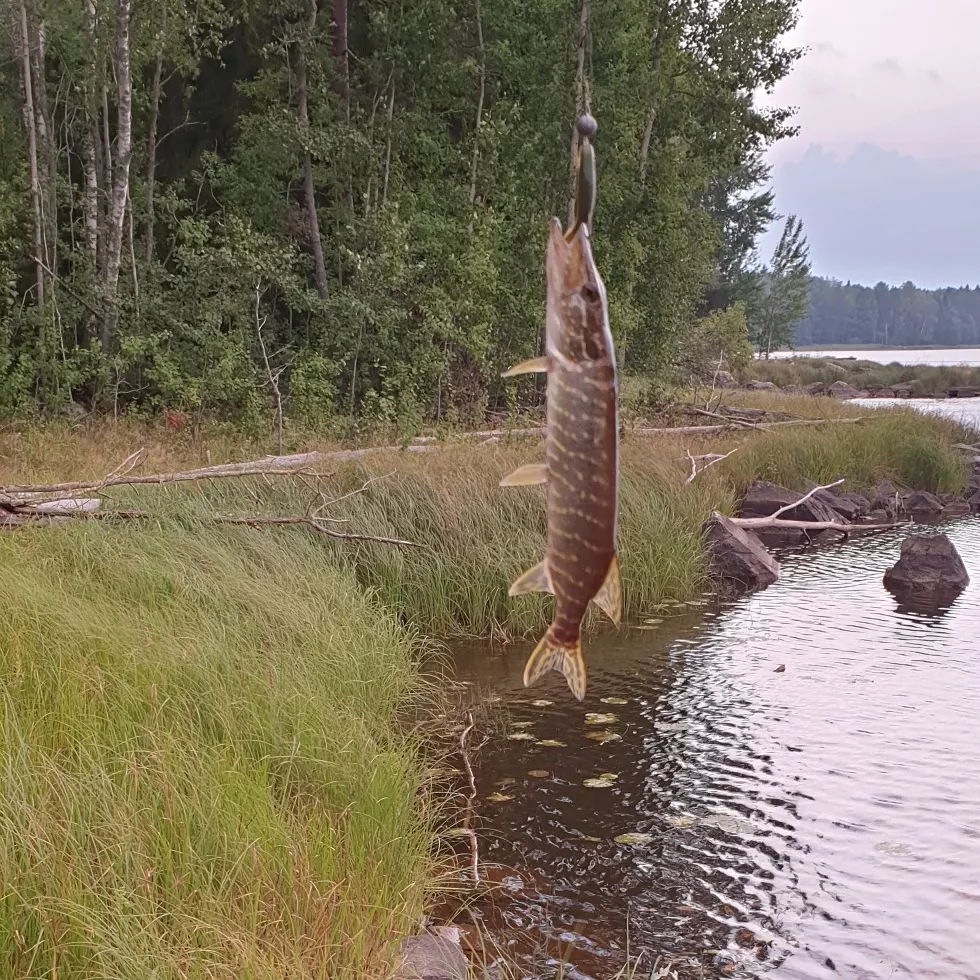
left=739, top=357, right=980, bottom=397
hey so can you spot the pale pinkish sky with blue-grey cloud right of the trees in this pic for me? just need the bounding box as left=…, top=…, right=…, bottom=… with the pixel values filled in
left=760, top=0, right=980, bottom=288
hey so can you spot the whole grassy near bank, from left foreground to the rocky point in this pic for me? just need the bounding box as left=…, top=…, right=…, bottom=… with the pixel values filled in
left=0, top=400, right=966, bottom=980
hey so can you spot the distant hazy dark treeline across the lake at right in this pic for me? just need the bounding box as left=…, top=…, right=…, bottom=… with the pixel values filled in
left=795, top=276, right=980, bottom=347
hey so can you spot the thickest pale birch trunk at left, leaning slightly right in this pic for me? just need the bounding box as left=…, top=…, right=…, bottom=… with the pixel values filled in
left=100, top=0, right=133, bottom=353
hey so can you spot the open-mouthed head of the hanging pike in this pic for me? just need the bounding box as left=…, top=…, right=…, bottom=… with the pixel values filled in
left=546, top=218, right=613, bottom=363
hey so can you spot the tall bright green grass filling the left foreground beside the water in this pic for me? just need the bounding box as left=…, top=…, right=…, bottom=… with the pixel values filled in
left=0, top=516, right=431, bottom=980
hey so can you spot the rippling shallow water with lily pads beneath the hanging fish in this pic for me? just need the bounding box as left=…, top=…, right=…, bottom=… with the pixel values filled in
left=448, top=517, right=980, bottom=980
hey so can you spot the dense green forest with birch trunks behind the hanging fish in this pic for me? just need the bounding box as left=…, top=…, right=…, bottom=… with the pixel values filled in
left=0, top=0, right=801, bottom=424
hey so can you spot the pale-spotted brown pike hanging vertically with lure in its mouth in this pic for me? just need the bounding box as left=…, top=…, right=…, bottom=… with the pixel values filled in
left=500, top=116, right=623, bottom=701
